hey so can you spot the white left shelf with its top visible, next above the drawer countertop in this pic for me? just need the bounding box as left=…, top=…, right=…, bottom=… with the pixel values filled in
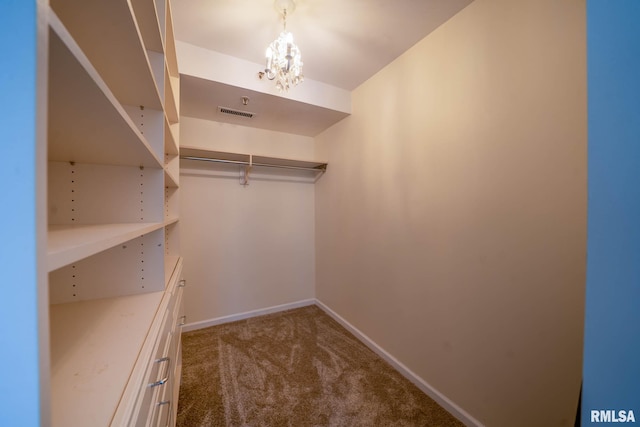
left=47, top=221, right=165, bottom=271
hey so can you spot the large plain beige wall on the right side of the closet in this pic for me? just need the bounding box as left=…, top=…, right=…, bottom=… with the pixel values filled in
left=316, top=0, right=587, bottom=426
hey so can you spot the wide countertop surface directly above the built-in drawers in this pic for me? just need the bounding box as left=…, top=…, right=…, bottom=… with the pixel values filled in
left=50, top=292, right=163, bottom=427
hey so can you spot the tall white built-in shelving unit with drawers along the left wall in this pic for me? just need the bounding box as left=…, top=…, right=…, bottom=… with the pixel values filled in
left=45, top=0, right=182, bottom=427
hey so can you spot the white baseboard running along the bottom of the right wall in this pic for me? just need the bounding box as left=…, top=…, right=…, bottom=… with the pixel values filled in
left=315, top=299, right=483, bottom=427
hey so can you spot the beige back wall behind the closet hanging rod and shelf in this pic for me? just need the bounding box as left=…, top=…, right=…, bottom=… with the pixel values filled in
left=180, top=117, right=315, bottom=323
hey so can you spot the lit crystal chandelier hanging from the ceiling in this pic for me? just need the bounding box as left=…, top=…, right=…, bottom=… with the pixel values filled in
left=260, top=0, right=304, bottom=92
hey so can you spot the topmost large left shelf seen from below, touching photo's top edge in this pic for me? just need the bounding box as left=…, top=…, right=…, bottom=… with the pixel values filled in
left=51, top=0, right=162, bottom=110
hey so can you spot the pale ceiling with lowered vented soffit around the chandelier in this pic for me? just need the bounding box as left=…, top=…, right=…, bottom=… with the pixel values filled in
left=172, top=0, right=471, bottom=136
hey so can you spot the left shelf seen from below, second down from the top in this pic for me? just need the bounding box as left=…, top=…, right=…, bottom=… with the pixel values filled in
left=48, top=13, right=162, bottom=168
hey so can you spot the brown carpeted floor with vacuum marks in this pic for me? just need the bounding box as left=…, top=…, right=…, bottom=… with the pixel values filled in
left=177, top=306, right=463, bottom=427
